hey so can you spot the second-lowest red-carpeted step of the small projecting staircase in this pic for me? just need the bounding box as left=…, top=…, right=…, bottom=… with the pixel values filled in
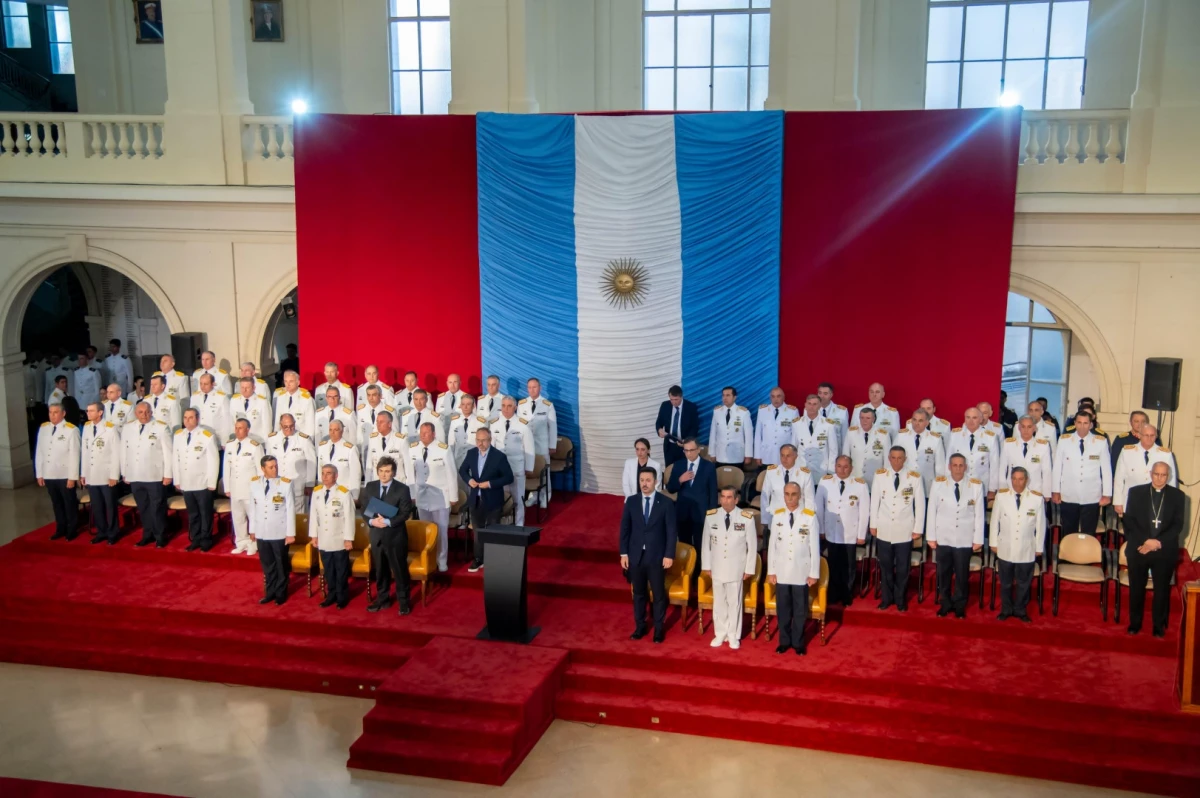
left=362, top=704, right=521, bottom=754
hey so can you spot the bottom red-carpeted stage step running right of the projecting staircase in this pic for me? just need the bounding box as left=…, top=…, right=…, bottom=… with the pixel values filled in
left=556, top=690, right=1200, bottom=796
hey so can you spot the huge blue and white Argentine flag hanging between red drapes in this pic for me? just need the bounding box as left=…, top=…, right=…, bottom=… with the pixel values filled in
left=476, top=112, right=784, bottom=493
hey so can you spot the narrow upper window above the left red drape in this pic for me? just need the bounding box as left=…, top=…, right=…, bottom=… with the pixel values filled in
left=388, top=0, right=450, bottom=114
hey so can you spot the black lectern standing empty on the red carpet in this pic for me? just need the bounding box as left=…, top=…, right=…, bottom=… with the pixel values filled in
left=475, top=526, right=541, bottom=643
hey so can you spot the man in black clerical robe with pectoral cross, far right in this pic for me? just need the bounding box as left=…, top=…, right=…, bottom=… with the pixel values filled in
left=1122, top=462, right=1187, bottom=637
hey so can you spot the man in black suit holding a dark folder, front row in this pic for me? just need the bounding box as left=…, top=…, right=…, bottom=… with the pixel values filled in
left=359, top=456, right=413, bottom=616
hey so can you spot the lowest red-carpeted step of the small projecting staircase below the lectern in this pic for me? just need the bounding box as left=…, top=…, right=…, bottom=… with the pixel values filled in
left=346, top=734, right=520, bottom=786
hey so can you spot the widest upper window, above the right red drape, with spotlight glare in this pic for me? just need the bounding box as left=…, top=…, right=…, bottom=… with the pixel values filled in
left=925, top=0, right=1088, bottom=109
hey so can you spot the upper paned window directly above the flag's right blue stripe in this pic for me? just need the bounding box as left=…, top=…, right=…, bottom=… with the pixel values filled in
left=642, top=0, right=770, bottom=110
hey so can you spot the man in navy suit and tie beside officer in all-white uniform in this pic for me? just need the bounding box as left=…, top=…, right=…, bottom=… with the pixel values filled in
left=620, top=467, right=676, bottom=643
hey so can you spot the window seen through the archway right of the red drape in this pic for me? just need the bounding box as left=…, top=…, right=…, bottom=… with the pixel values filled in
left=1001, top=293, right=1070, bottom=420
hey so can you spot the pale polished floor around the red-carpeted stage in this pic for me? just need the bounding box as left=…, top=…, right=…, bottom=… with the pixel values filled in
left=0, top=487, right=1152, bottom=798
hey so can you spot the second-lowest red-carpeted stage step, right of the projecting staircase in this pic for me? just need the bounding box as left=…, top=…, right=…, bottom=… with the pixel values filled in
left=563, top=664, right=1200, bottom=758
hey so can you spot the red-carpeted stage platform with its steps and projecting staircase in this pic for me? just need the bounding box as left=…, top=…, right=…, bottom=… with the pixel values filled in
left=0, top=494, right=1200, bottom=796
